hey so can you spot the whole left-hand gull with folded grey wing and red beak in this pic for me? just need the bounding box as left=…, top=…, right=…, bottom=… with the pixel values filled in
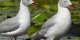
left=0, top=0, right=37, bottom=40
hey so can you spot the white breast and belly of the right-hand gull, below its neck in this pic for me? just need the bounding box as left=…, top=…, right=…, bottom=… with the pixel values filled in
left=44, top=11, right=71, bottom=37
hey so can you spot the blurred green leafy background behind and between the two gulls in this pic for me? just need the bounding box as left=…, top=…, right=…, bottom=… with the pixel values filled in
left=0, top=0, right=80, bottom=40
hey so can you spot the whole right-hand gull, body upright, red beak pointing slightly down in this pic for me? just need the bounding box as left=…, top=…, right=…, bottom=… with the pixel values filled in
left=28, top=0, right=76, bottom=40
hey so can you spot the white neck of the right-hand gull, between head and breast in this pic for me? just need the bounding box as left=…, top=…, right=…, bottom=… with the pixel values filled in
left=56, top=3, right=71, bottom=17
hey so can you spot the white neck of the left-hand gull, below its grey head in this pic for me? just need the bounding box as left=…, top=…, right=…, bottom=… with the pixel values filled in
left=16, top=0, right=30, bottom=17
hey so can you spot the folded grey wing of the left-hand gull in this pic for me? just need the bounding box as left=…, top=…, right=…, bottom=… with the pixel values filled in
left=0, top=17, right=20, bottom=33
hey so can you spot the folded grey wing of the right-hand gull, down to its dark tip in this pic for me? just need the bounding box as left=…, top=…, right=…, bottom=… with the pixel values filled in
left=31, top=19, right=54, bottom=39
